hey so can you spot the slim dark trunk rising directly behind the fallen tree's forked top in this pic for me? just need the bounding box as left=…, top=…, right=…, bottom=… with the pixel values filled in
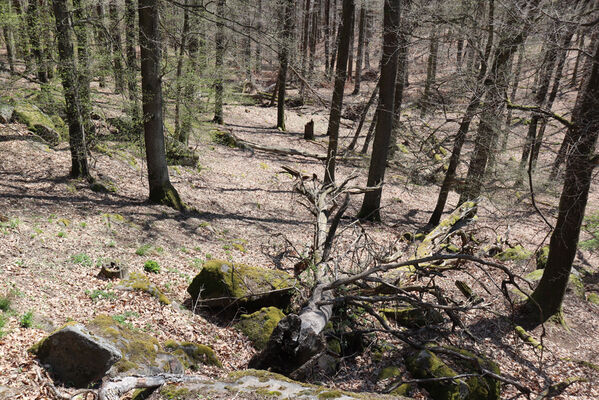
left=324, top=0, right=355, bottom=183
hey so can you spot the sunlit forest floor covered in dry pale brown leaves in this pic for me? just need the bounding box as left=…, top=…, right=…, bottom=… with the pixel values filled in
left=0, top=64, right=599, bottom=399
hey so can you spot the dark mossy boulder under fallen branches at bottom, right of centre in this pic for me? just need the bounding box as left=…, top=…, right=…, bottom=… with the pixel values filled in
left=406, top=346, right=501, bottom=400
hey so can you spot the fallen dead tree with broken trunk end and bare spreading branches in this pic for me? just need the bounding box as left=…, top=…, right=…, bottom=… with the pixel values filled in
left=249, top=177, right=531, bottom=395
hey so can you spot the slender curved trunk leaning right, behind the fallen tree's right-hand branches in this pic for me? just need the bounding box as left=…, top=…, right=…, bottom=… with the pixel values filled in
left=427, top=0, right=495, bottom=227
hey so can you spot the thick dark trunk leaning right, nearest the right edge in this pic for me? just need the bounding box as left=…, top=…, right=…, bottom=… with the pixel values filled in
left=528, top=33, right=599, bottom=322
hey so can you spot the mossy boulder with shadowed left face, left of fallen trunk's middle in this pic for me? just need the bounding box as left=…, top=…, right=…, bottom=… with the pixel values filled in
left=187, top=260, right=295, bottom=311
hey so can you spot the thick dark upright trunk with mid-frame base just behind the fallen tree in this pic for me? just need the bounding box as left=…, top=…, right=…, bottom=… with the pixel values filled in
left=358, top=0, right=402, bottom=221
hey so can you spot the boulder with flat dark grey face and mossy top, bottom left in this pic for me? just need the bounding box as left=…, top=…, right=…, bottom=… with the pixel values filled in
left=30, top=315, right=183, bottom=387
